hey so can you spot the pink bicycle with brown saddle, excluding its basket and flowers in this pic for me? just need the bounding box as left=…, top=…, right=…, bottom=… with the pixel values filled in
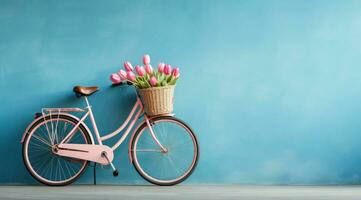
left=21, top=82, right=199, bottom=186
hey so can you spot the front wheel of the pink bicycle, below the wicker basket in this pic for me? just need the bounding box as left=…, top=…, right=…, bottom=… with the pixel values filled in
left=131, top=117, right=199, bottom=186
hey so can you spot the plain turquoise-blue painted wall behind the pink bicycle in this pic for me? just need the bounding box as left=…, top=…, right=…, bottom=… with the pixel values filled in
left=0, top=0, right=361, bottom=184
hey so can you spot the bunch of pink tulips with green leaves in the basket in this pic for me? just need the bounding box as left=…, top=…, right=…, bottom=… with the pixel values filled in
left=110, top=55, right=180, bottom=89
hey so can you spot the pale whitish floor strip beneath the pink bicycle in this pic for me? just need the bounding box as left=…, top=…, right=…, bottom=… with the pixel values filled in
left=0, top=185, right=361, bottom=200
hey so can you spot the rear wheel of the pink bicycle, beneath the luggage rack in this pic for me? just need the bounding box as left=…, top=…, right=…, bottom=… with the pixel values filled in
left=23, top=114, right=92, bottom=186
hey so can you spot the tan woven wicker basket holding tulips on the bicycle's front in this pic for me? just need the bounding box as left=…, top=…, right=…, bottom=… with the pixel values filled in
left=138, top=85, right=175, bottom=116
